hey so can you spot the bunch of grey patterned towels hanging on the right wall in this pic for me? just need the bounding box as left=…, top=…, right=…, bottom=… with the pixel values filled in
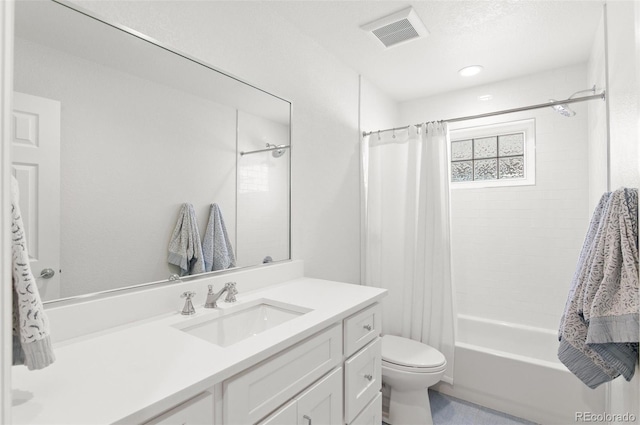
left=558, top=189, right=639, bottom=388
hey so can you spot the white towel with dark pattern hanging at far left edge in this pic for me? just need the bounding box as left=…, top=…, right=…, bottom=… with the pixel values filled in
left=11, top=176, right=55, bottom=370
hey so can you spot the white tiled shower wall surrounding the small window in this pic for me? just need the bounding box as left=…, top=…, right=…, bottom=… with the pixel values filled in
left=401, top=64, right=592, bottom=329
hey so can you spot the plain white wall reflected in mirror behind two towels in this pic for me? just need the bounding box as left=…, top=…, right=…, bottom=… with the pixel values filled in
left=15, top=39, right=236, bottom=297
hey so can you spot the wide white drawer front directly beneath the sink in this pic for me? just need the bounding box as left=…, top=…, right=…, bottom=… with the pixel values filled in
left=223, top=324, right=342, bottom=424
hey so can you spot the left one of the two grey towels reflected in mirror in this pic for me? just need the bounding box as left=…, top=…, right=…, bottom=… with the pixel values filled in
left=168, top=203, right=205, bottom=276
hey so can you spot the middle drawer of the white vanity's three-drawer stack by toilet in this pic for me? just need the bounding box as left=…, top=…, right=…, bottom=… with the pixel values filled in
left=344, top=338, right=382, bottom=423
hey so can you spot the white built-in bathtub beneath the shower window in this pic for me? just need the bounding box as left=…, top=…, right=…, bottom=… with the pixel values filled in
left=434, top=315, right=605, bottom=425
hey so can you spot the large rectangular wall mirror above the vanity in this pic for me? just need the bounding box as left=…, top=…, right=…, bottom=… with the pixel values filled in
left=12, top=0, right=291, bottom=301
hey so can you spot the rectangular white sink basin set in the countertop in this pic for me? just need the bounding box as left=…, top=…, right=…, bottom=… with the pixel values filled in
left=179, top=300, right=311, bottom=347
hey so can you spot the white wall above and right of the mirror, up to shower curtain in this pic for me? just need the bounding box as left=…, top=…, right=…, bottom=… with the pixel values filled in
left=62, top=1, right=368, bottom=283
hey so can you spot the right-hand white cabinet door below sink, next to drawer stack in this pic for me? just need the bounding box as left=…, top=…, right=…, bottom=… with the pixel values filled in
left=296, top=368, right=342, bottom=425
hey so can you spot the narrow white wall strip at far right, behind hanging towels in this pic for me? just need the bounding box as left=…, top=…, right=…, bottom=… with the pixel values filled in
left=606, top=1, right=640, bottom=423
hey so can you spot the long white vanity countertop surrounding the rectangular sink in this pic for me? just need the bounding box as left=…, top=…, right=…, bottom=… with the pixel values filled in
left=12, top=278, right=386, bottom=425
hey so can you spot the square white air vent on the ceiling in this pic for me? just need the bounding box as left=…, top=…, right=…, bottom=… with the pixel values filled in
left=360, top=7, right=429, bottom=47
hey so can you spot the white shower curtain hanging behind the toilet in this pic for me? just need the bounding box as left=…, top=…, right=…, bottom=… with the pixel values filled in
left=362, top=122, right=455, bottom=384
